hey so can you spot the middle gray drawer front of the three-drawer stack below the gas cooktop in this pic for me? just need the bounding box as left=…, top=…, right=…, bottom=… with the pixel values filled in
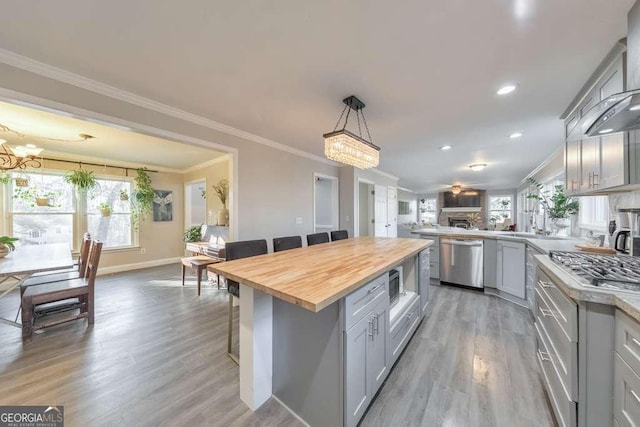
left=536, top=290, right=578, bottom=402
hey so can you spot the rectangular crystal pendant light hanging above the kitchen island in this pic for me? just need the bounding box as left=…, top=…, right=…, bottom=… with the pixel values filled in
left=322, top=96, right=380, bottom=169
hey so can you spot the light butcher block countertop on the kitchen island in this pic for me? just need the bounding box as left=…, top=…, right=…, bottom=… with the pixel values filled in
left=209, top=237, right=433, bottom=312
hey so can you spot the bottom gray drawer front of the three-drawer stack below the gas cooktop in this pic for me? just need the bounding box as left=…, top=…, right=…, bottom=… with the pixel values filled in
left=535, top=323, right=578, bottom=427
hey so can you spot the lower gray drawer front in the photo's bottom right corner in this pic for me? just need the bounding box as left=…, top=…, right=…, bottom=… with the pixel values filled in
left=613, top=353, right=640, bottom=427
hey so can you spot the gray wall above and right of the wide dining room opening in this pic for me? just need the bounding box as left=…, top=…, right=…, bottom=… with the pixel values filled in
left=0, top=64, right=340, bottom=256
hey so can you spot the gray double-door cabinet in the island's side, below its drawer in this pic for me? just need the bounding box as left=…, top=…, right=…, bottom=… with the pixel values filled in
left=344, top=299, right=391, bottom=426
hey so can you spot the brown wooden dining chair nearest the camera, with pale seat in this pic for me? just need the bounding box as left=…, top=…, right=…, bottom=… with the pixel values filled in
left=21, top=240, right=102, bottom=338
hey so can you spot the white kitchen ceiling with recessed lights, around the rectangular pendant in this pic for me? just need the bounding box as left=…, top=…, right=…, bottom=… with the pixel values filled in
left=0, top=0, right=633, bottom=191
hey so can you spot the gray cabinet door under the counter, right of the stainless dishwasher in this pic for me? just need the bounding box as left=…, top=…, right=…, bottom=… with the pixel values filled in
left=496, top=241, right=525, bottom=299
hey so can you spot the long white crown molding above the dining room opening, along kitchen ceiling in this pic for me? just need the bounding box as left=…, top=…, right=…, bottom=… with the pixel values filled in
left=0, top=49, right=338, bottom=166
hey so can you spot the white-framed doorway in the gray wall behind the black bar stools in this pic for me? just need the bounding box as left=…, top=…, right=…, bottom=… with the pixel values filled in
left=313, top=173, right=339, bottom=233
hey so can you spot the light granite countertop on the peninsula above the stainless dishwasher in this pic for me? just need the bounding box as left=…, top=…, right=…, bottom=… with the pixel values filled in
left=411, top=228, right=585, bottom=254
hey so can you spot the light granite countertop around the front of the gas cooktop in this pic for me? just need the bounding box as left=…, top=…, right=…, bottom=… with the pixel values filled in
left=535, top=255, right=640, bottom=322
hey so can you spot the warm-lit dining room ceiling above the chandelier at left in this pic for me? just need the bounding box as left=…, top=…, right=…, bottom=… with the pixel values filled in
left=0, top=102, right=224, bottom=172
